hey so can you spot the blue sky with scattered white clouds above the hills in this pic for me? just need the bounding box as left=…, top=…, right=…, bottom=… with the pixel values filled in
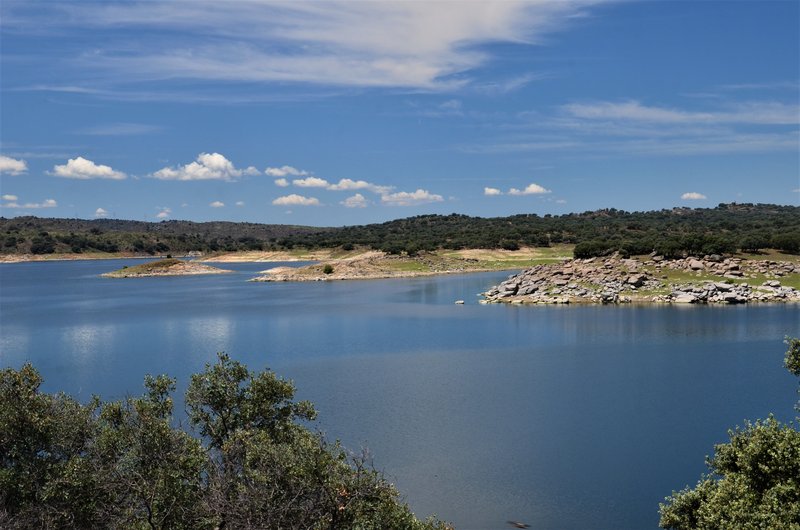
left=0, top=0, right=800, bottom=226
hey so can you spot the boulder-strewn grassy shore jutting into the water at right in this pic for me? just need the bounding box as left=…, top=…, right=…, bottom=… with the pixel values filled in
left=481, top=255, right=800, bottom=304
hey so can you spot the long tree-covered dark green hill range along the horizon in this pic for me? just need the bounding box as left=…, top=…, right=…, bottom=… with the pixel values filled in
left=0, top=203, right=800, bottom=257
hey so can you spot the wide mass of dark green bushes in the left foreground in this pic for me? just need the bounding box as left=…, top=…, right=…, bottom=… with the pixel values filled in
left=0, top=354, right=448, bottom=530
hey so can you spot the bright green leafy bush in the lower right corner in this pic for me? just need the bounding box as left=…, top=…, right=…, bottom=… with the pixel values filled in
left=660, top=339, right=800, bottom=530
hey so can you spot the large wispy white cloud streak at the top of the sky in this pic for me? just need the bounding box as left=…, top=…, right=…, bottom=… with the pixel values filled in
left=50, top=0, right=598, bottom=90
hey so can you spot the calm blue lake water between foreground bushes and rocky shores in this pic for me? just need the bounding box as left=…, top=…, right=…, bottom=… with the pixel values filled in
left=0, top=260, right=800, bottom=530
